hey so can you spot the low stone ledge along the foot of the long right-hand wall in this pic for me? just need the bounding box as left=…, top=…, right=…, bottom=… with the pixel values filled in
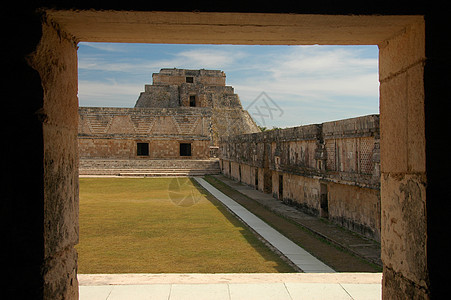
left=213, top=175, right=382, bottom=266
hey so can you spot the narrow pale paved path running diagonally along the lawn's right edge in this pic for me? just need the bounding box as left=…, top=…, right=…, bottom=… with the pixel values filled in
left=194, top=177, right=335, bottom=273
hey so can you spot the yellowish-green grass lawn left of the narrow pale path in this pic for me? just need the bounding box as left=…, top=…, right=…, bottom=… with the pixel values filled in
left=76, top=178, right=293, bottom=274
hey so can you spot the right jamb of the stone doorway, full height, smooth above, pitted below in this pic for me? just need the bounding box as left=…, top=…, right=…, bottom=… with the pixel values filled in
left=379, top=22, right=429, bottom=299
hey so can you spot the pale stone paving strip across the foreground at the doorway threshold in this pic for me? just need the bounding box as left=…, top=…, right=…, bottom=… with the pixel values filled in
left=78, top=273, right=382, bottom=300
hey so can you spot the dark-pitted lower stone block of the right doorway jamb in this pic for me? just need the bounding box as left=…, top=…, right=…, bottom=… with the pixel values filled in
left=381, top=174, right=428, bottom=287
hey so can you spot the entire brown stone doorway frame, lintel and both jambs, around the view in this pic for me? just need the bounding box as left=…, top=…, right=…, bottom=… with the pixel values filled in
left=29, top=10, right=429, bottom=299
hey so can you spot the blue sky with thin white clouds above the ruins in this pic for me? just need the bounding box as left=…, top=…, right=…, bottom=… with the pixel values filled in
left=78, top=43, right=379, bottom=128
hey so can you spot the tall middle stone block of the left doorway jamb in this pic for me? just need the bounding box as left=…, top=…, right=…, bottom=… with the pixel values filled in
left=44, top=125, right=78, bottom=258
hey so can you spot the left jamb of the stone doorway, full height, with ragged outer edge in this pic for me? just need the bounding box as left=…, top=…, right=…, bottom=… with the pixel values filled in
left=29, top=14, right=78, bottom=299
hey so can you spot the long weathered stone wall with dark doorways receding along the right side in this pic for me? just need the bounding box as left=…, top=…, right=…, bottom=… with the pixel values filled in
left=220, top=115, right=381, bottom=241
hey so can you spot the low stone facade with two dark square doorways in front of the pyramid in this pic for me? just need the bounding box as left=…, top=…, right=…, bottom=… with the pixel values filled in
left=78, top=107, right=211, bottom=159
